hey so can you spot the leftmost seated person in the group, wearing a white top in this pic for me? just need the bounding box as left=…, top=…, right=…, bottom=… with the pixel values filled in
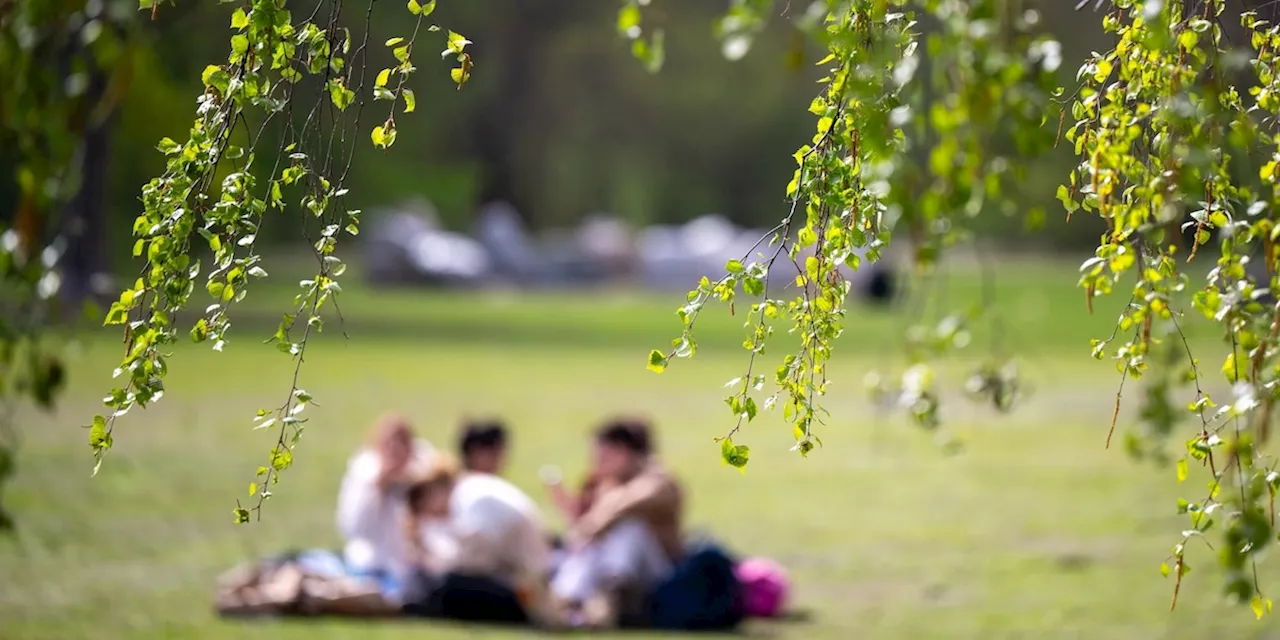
left=337, top=415, right=436, bottom=600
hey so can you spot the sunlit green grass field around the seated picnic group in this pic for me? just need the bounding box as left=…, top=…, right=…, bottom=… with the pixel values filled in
left=0, top=256, right=1280, bottom=639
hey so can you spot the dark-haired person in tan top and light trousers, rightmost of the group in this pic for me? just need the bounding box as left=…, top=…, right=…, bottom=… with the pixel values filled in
left=550, top=419, right=684, bottom=627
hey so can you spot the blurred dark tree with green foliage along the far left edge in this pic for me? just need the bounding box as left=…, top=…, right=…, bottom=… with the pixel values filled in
left=0, top=0, right=133, bottom=526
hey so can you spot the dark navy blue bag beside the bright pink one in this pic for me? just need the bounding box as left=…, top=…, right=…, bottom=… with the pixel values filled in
left=649, top=543, right=742, bottom=631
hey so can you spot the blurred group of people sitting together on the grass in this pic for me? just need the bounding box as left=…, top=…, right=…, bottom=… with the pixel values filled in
left=338, top=416, right=685, bottom=628
